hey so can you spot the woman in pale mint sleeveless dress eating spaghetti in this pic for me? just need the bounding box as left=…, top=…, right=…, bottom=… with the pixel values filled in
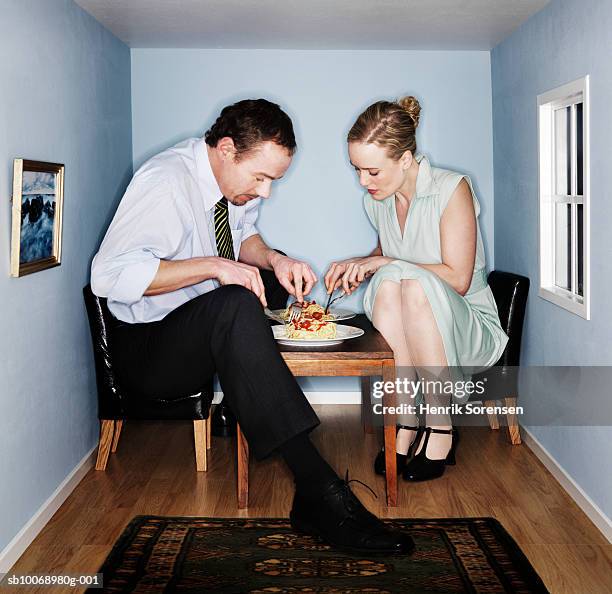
left=325, top=96, right=508, bottom=481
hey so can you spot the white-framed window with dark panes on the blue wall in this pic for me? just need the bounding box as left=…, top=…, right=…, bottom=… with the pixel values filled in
left=538, top=76, right=590, bottom=320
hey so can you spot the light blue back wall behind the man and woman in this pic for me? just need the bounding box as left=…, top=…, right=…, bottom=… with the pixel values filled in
left=132, top=49, right=493, bottom=391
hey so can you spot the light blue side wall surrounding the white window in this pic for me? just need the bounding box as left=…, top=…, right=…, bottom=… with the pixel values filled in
left=491, top=0, right=612, bottom=517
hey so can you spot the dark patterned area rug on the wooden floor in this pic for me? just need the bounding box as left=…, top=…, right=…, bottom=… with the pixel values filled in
left=92, top=516, right=547, bottom=594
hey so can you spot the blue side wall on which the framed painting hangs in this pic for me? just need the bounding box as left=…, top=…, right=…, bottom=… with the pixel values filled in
left=0, top=0, right=132, bottom=551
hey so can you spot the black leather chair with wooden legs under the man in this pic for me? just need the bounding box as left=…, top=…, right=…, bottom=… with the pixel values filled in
left=83, top=285, right=213, bottom=471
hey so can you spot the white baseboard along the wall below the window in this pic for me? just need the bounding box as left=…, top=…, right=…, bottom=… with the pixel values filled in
left=521, top=425, right=612, bottom=544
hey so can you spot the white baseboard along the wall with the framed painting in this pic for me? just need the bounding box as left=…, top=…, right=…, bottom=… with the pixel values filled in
left=0, top=444, right=98, bottom=574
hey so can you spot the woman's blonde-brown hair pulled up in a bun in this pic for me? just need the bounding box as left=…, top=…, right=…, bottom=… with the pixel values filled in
left=347, top=95, right=421, bottom=161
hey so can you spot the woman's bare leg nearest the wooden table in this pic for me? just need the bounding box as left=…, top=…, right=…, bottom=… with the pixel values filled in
left=372, top=281, right=419, bottom=454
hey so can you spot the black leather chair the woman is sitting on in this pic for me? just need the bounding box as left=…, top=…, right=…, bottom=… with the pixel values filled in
left=471, top=270, right=529, bottom=445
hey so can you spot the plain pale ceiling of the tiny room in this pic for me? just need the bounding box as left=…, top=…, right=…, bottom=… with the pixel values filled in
left=76, top=0, right=549, bottom=50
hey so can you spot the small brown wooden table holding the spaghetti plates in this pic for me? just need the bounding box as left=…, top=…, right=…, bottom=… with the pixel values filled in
left=238, top=314, right=397, bottom=508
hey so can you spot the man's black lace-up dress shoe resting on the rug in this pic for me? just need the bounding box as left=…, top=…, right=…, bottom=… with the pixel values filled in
left=289, top=478, right=414, bottom=555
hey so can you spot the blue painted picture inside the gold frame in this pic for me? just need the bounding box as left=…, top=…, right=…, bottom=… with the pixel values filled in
left=19, top=171, right=56, bottom=264
